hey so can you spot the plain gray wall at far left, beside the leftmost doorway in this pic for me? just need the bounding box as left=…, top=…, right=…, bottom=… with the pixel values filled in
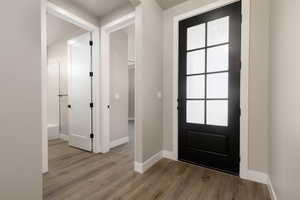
left=0, top=0, right=42, bottom=200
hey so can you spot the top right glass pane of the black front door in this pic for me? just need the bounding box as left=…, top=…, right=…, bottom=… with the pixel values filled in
left=207, top=17, right=229, bottom=46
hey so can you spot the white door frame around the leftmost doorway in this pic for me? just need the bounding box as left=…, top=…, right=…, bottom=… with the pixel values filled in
left=41, top=0, right=101, bottom=173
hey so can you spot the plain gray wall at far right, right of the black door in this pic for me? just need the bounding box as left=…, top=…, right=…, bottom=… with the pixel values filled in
left=269, top=0, right=300, bottom=200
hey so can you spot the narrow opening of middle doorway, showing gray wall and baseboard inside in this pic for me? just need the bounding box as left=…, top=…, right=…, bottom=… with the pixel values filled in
left=109, top=21, right=135, bottom=160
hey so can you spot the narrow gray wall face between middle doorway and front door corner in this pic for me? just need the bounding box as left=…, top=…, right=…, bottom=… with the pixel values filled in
left=135, top=0, right=163, bottom=162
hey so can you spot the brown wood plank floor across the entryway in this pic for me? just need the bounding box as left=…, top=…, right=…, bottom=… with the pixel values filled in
left=43, top=140, right=270, bottom=200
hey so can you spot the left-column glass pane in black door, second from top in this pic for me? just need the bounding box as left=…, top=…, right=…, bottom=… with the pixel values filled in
left=186, top=50, right=205, bottom=74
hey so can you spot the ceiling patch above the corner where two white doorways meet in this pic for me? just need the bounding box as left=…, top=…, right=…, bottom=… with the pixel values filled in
left=53, top=0, right=131, bottom=18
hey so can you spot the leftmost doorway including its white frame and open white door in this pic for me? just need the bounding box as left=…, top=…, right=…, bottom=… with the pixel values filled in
left=42, top=2, right=100, bottom=173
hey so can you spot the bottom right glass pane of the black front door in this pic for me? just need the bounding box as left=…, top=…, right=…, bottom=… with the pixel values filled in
left=206, top=100, right=228, bottom=126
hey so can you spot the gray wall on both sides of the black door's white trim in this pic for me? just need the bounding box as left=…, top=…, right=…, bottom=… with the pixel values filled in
left=163, top=0, right=269, bottom=172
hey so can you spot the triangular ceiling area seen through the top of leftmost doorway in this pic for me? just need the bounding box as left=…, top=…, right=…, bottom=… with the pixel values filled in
left=47, top=14, right=86, bottom=45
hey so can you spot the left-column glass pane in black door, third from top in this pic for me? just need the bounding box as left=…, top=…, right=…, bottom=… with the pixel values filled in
left=186, top=75, right=205, bottom=99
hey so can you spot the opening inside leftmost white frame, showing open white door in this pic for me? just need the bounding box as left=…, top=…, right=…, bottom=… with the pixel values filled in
left=47, top=14, right=94, bottom=152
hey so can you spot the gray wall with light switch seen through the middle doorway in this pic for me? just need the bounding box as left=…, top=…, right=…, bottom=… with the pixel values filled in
left=110, top=30, right=129, bottom=142
